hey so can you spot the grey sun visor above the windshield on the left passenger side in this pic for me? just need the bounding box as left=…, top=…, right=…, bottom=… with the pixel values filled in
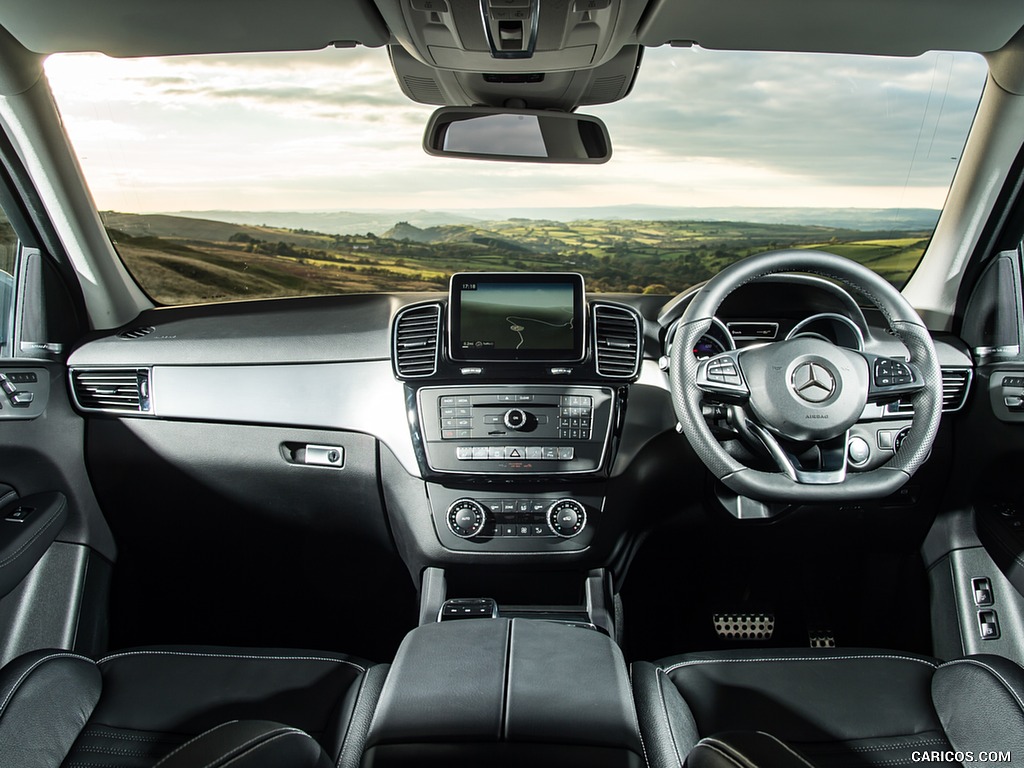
left=0, top=0, right=389, bottom=56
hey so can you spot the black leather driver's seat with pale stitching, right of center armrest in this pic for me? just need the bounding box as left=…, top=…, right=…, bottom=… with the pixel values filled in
left=632, top=650, right=1024, bottom=768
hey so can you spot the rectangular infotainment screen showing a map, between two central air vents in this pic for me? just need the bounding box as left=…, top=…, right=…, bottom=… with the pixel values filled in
left=449, top=272, right=586, bottom=362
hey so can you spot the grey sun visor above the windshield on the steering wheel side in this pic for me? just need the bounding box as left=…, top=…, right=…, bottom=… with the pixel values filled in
left=638, top=0, right=1024, bottom=56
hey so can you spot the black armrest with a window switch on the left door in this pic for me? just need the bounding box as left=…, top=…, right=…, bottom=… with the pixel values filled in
left=0, top=493, right=68, bottom=597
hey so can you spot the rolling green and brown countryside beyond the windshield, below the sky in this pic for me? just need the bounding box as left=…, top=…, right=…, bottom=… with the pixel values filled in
left=103, top=213, right=929, bottom=304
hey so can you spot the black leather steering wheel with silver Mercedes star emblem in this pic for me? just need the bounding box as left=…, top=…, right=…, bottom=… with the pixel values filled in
left=669, top=250, right=942, bottom=503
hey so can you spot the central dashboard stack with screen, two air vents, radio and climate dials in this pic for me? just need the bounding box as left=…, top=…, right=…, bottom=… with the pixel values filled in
left=392, top=272, right=643, bottom=553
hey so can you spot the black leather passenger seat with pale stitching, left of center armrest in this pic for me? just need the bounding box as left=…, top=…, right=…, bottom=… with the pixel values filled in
left=0, top=647, right=387, bottom=768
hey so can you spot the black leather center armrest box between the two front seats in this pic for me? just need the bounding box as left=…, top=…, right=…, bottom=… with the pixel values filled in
left=362, top=617, right=645, bottom=768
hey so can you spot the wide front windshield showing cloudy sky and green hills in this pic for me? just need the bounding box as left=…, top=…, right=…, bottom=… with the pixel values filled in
left=46, top=48, right=986, bottom=304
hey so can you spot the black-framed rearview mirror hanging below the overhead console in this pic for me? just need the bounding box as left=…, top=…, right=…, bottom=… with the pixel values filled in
left=423, top=106, right=611, bottom=163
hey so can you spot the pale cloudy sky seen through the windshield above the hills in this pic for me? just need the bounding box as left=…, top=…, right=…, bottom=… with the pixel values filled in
left=46, top=47, right=986, bottom=213
